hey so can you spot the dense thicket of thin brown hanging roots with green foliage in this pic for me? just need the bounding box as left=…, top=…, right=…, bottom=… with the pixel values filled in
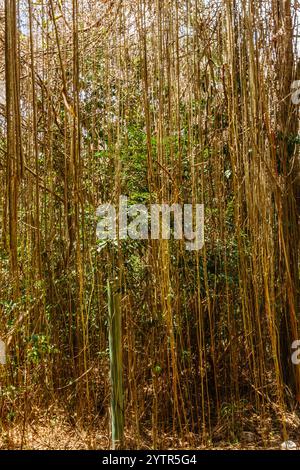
left=0, top=0, right=300, bottom=448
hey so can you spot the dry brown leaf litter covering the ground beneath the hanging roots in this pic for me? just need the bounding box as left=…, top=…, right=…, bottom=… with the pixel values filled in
left=0, top=415, right=292, bottom=450
